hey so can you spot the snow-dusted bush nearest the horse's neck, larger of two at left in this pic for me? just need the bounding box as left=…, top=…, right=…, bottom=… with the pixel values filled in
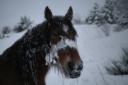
left=14, top=16, right=32, bottom=32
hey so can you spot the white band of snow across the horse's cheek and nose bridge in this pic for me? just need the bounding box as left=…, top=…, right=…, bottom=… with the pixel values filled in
left=45, top=37, right=77, bottom=64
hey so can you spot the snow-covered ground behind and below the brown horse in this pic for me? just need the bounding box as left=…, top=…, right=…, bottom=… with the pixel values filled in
left=0, top=25, right=128, bottom=85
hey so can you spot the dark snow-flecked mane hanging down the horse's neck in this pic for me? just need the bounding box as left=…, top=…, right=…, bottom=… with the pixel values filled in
left=18, top=23, right=49, bottom=85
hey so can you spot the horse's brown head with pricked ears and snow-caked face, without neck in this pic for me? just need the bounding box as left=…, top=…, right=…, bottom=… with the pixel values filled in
left=45, top=7, right=83, bottom=78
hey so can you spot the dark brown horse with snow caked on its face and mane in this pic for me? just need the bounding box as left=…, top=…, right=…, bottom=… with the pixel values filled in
left=0, top=6, right=83, bottom=85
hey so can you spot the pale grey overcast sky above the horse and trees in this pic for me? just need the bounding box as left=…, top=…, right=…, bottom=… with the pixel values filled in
left=0, top=0, right=104, bottom=28
